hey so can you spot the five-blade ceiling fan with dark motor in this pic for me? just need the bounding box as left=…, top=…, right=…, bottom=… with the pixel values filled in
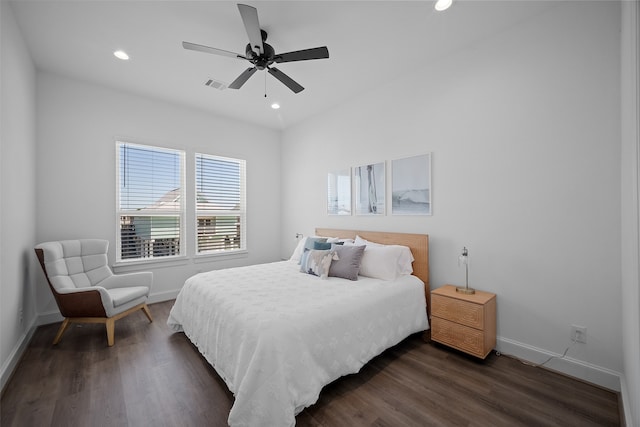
left=182, top=4, right=329, bottom=93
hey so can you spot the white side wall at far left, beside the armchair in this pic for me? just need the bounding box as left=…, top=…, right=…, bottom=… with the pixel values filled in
left=0, top=1, right=36, bottom=388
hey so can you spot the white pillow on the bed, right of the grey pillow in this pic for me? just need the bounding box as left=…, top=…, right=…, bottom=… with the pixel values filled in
left=355, top=236, right=415, bottom=280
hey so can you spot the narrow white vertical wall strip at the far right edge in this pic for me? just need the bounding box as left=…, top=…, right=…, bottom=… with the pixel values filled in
left=621, top=1, right=640, bottom=426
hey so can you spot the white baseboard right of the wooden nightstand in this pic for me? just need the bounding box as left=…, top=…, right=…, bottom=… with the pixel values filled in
left=496, top=337, right=622, bottom=392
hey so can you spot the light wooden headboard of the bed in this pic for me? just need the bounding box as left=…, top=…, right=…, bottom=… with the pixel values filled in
left=316, top=228, right=431, bottom=315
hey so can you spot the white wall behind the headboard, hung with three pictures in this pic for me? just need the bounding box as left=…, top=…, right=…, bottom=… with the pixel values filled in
left=282, top=2, right=622, bottom=389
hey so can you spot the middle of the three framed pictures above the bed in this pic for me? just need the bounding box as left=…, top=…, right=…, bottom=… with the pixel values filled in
left=353, top=162, right=386, bottom=215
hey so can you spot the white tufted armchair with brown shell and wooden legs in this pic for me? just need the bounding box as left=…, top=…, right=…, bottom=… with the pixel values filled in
left=35, top=239, right=153, bottom=346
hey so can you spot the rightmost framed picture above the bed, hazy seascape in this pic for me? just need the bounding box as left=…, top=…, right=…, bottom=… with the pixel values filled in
left=391, top=153, right=432, bottom=215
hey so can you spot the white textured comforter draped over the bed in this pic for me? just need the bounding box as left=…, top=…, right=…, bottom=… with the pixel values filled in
left=167, top=261, right=429, bottom=427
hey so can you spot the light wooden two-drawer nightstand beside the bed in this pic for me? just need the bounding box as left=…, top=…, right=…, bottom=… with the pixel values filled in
left=431, top=285, right=496, bottom=359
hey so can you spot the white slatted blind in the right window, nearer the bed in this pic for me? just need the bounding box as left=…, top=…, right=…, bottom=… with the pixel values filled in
left=195, top=153, right=246, bottom=254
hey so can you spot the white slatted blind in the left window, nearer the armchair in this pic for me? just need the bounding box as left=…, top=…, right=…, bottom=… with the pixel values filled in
left=116, top=142, right=185, bottom=261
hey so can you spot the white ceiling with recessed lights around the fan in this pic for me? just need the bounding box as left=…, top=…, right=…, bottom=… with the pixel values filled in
left=8, top=0, right=552, bottom=129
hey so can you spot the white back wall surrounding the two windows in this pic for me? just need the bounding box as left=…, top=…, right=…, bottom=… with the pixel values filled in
left=36, top=72, right=280, bottom=314
